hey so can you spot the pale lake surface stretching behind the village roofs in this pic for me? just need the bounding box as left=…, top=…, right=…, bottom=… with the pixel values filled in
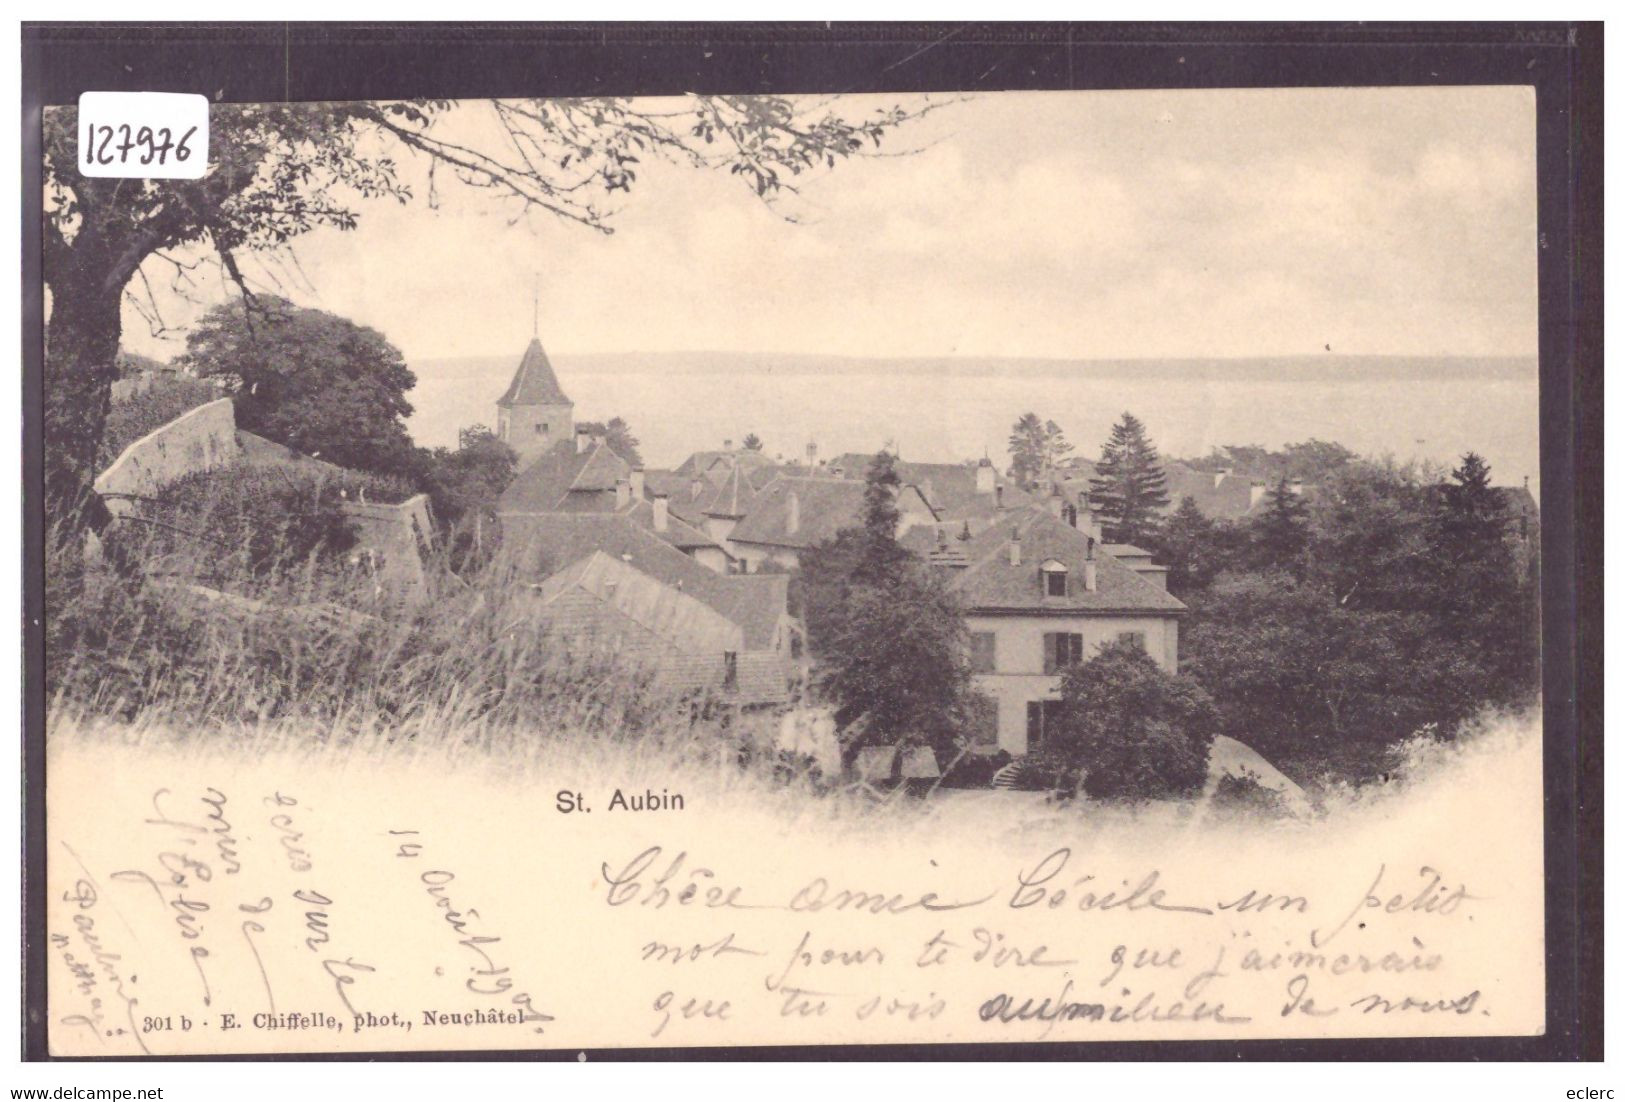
left=410, top=353, right=1539, bottom=491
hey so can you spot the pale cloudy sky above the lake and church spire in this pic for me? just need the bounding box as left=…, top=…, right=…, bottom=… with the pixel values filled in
left=125, top=88, right=1537, bottom=362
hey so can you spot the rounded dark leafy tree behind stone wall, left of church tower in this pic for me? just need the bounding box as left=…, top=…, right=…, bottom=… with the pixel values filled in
left=180, top=294, right=418, bottom=478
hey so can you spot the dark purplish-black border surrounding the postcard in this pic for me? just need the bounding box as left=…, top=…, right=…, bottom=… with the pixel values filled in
left=21, top=23, right=1604, bottom=1061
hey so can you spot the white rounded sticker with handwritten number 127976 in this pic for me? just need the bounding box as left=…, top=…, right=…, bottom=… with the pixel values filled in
left=80, top=93, right=208, bottom=180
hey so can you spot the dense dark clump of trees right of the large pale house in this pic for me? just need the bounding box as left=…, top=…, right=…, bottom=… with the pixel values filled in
left=1165, top=455, right=1539, bottom=780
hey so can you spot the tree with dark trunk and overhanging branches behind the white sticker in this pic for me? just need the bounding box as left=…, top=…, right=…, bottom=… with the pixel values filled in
left=44, top=96, right=918, bottom=528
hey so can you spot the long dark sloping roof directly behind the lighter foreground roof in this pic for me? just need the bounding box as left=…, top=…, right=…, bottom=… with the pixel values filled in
left=502, top=514, right=790, bottom=650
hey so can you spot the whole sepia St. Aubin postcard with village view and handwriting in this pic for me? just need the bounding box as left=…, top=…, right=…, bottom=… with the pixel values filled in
left=44, top=85, right=1547, bottom=1056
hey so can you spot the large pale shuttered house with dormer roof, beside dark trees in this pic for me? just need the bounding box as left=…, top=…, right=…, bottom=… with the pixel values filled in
left=908, top=507, right=1186, bottom=756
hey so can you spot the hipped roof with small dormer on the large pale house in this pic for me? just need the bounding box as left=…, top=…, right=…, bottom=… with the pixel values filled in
left=949, top=509, right=1185, bottom=614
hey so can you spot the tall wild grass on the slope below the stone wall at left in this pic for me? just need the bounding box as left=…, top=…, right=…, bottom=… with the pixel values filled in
left=47, top=503, right=757, bottom=763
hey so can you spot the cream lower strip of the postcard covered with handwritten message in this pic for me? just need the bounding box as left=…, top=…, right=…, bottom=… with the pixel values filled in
left=38, top=737, right=1544, bottom=1055
